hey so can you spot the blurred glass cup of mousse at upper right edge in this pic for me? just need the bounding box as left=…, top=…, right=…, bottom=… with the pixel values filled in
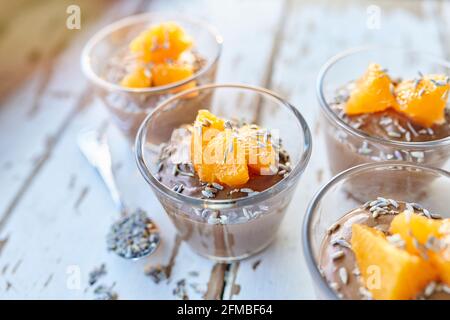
left=317, top=47, right=450, bottom=174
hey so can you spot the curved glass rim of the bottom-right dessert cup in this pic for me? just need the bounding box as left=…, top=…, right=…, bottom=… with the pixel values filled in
left=301, top=161, right=450, bottom=299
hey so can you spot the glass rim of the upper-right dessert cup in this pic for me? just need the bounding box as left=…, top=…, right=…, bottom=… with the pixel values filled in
left=316, top=46, right=450, bottom=150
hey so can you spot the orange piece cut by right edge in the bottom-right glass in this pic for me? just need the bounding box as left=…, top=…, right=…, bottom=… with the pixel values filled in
left=390, top=212, right=450, bottom=285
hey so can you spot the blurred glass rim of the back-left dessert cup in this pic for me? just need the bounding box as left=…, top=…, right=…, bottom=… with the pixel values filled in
left=81, top=12, right=223, bottom=93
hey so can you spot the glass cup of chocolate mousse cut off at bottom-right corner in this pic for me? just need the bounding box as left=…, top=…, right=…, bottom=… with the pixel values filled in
left=302, top=161, right=450, bottom=300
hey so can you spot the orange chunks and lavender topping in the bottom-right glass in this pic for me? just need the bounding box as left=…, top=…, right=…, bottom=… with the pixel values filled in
left=340, top=201, right=450, bottom=299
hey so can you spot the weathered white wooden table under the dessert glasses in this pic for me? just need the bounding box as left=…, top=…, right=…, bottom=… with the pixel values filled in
left=0, top=0, right=450, bottom=299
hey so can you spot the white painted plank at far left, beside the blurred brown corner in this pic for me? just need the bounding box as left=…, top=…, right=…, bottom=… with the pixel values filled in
left=0, top=2, right=142, bottom=225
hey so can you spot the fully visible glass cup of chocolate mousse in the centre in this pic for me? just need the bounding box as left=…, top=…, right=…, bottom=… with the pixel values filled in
left=135, top=84, right=311, bottom=262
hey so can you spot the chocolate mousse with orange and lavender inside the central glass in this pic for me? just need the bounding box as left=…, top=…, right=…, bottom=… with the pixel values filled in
left=154, top=110, right=291, bottom=260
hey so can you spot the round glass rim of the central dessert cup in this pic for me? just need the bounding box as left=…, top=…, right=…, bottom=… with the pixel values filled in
left=135, top=83, right=312, bottom=209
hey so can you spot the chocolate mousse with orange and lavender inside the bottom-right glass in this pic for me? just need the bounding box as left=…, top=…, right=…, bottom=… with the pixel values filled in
left=319, top=197, right=450, bottom=300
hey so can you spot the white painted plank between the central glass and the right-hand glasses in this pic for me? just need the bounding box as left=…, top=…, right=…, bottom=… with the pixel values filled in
left=230, top=1, right=448, bottom=299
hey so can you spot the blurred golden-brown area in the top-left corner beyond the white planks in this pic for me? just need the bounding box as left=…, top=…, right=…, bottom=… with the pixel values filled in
left=0, top=0, right=113, bottom=102
